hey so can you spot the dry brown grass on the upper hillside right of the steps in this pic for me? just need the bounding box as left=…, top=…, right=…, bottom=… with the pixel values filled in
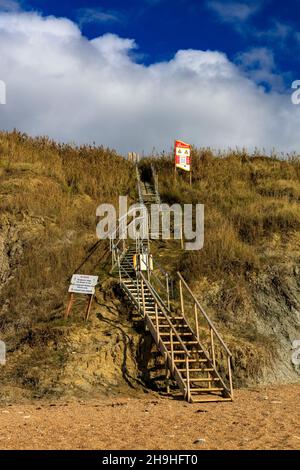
left=143, top=149, right=300, bottom=280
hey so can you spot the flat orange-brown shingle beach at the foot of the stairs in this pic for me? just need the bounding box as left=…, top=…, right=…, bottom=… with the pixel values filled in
left=0, top=385, right=300, bottom=450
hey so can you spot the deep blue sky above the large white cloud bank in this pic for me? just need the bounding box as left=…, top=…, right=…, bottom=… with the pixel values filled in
left=23, top=0, right=300, bottom=86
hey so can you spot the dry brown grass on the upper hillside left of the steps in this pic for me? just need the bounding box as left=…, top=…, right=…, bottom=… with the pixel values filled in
left=0, top=132, right=134, bottom=329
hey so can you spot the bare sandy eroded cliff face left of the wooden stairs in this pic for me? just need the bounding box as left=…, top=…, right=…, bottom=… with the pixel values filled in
left=0, top=233, right=164, bottom=402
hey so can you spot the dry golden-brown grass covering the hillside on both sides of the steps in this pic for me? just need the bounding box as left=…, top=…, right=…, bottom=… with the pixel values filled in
left=0, top=132, right=300, bottom=394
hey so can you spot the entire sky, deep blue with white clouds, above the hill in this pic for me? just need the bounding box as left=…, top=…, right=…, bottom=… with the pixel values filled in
left=0, top=0, right=300, bottom=153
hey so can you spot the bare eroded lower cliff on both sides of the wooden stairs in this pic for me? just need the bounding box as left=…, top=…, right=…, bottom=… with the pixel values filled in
left=0, top=212, right=300, bottom=401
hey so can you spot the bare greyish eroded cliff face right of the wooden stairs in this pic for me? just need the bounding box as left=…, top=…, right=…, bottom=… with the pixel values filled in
left=194, top=233, right=300, bottom=386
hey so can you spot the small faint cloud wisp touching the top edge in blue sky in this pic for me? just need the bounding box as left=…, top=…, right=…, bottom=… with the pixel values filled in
left=207, top=0, right=260, bottom=23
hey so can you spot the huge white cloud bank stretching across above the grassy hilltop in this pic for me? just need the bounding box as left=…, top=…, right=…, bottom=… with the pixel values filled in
left=0, top=9, right=300, bottom=152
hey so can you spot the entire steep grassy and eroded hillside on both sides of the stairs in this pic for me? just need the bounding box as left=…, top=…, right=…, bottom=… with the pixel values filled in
left=0, top=132, right=300, bottom=400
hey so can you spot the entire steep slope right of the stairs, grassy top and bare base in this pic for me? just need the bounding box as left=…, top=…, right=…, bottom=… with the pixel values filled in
left=142, top=149, right=300, bottom=385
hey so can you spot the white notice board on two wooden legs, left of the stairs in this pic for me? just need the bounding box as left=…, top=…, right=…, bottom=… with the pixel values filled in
left=65, top=274, right=98, bottom=321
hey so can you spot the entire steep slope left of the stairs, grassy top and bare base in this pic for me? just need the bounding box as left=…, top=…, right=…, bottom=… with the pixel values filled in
left=0, top=133, right=146, bottom=397
